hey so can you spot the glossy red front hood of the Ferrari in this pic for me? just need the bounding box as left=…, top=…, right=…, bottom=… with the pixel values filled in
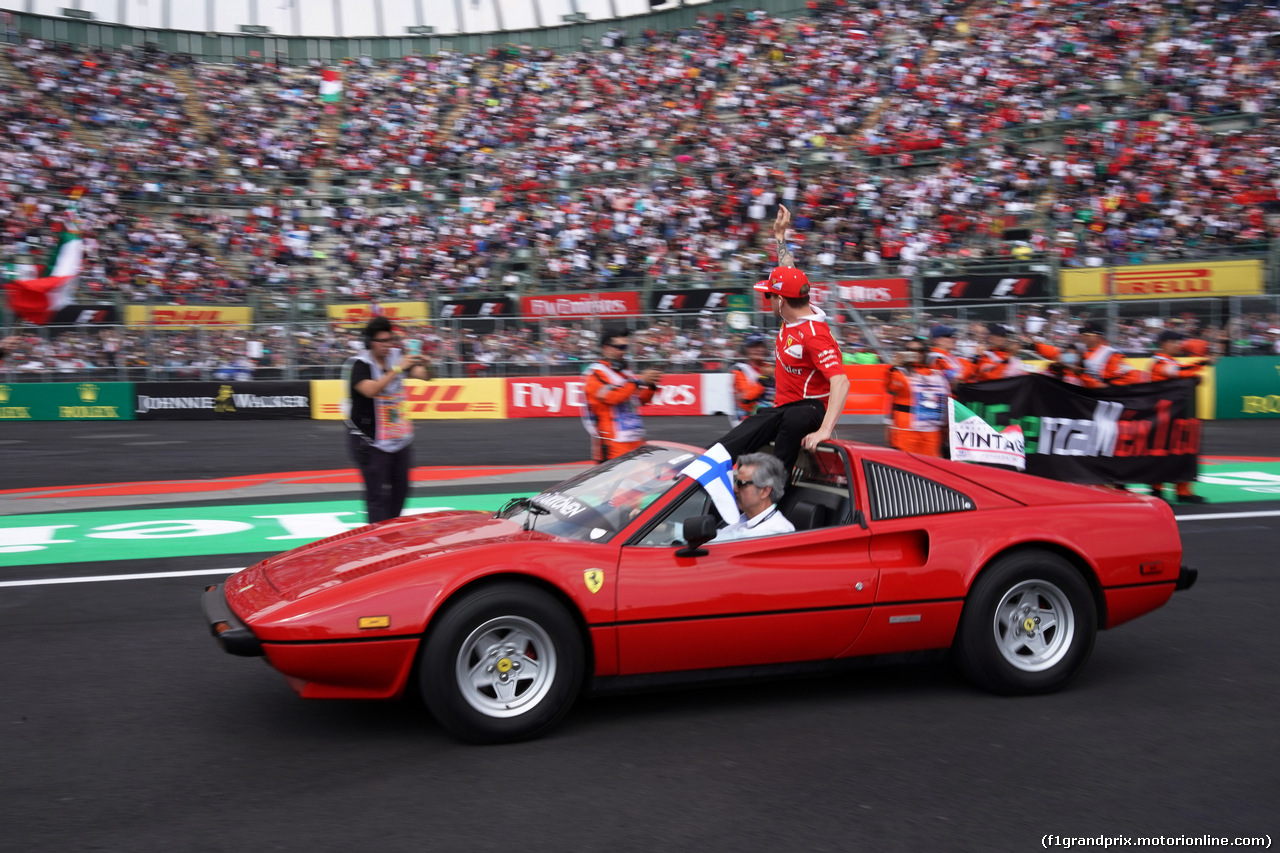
left=257, top=512, right=538, bottom=601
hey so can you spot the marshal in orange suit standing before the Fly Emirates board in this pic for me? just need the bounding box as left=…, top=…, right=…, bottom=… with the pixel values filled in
left=582, top=329, right=662, bottom=462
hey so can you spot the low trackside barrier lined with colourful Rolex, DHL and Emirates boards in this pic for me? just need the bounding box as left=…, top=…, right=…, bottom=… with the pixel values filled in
left=0, top=356, right=1249, bottom=423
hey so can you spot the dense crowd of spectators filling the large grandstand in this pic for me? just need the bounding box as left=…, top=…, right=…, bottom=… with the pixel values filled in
left=0, top=0, right=1280, bottom=371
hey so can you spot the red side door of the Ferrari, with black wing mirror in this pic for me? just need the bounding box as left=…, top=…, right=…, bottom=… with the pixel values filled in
left=617, top=496, right=877, bottom=675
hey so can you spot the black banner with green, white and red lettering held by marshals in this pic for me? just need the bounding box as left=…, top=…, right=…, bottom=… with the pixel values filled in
left=955, top=375, right=1201, bottom=484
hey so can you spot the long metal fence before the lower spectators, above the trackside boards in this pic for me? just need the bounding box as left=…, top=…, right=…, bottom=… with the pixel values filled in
left=0, top=296, right=1280, bottom=382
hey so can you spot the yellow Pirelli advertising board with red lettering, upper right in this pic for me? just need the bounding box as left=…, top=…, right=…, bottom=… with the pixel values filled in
left=1059, top=260, right=1263, bottom=302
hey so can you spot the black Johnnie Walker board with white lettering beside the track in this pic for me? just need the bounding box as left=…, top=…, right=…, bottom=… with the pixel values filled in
left=133, top=382, right=311, bottom=420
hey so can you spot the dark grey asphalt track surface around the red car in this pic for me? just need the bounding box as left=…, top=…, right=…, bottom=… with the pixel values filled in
left=0, top=419, right=1280, bottom=852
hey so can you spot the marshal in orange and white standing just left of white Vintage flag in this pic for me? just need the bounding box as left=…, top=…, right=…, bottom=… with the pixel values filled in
left=884, top=338, right=951, bottom=457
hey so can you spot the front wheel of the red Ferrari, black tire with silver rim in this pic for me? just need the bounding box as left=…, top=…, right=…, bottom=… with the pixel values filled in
left=419, top=583, right=585, bottom=743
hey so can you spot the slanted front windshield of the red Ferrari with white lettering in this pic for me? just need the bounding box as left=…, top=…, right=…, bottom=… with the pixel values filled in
left=498, top=444, right=696, bottom=542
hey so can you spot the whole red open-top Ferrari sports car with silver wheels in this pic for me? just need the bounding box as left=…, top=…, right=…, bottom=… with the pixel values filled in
left=204, top=442, right=1196, bottom=742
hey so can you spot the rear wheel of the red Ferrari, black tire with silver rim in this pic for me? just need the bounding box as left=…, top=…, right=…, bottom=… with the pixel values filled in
left=952, top=551, right=1098, bottom=695
